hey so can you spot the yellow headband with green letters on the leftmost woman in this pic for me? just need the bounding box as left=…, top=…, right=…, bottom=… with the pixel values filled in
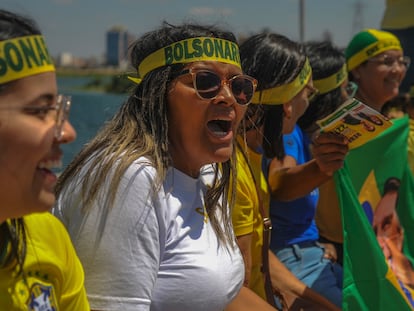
left=0, top=35, right=55, bottom=84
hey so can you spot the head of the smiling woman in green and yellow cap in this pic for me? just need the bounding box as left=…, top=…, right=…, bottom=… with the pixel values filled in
left=345, top=29, right=410, bottom=111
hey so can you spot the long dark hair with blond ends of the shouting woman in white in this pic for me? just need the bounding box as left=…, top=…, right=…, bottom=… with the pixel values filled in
left=56, top=22, right=236, bottom=249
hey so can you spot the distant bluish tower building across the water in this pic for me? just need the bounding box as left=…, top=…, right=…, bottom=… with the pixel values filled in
left=106, top=26, right=132, bottom=67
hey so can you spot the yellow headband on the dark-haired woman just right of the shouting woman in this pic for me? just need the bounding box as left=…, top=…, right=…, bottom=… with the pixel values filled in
left=252, top=58, right=312, bottom=105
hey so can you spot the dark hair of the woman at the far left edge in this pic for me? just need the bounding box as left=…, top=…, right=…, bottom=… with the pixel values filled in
left=0, top=9, right=41, bottom=273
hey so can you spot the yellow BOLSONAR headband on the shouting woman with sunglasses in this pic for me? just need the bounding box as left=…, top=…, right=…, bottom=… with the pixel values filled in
left=130, top=37, right=241, bottom=83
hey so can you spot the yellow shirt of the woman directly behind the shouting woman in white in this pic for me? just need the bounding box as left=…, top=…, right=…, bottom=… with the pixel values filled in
left=232, top=140, right=269, bottom=299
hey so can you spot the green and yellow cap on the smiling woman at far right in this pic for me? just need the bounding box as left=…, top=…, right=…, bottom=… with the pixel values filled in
left=345, top=29, right=402, bottom=71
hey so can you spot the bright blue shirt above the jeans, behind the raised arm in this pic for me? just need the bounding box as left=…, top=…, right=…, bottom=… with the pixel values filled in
left=265, top=125, right=319, bottom=249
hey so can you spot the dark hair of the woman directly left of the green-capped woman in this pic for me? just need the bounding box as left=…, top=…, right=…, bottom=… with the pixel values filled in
left=298, top=41, right=345, bottom=131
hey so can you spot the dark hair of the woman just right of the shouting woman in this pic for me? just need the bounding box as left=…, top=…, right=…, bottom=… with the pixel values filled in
left=240, top=32, right=306, bottom=159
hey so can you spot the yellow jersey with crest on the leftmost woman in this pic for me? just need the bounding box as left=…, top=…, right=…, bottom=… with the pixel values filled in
left=0, top=213, right=89, bottom=311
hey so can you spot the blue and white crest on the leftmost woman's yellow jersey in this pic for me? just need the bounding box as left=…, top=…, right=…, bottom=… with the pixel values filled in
left=27, top=283, right=59, bottom=311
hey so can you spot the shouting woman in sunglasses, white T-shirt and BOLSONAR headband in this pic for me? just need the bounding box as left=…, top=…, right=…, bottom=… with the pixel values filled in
left=54, top=23, right=256, bottom=311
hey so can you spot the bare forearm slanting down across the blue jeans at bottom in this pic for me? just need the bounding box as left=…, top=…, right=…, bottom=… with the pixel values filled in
left=269, top=250, right=341, bottom=311
